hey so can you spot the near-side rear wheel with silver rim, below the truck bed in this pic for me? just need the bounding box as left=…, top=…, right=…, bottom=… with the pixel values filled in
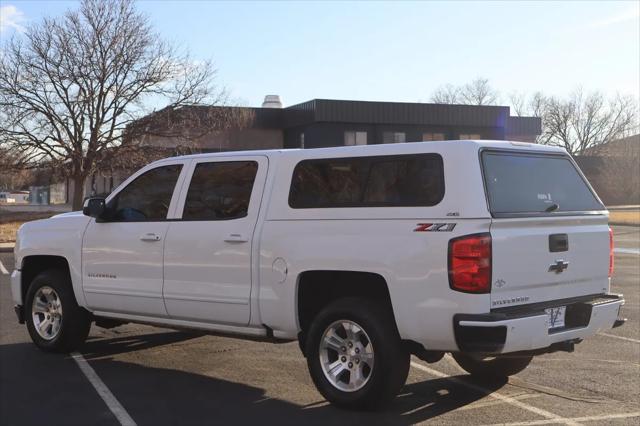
left=305, top=298, right=409, bottom=410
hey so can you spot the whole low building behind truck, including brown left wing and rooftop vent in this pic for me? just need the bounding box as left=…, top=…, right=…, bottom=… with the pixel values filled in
left=138, top=95, right=541, bottom=151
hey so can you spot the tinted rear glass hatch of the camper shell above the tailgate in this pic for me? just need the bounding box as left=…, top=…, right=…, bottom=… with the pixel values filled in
left=482, top=151, right=604, bottom=216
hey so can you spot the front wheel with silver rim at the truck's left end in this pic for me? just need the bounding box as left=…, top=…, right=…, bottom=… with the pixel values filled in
left=24, top=269, right=91, bottom=352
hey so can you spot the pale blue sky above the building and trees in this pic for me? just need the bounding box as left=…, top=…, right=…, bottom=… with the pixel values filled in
left=0, top=0, right=640, bottom=106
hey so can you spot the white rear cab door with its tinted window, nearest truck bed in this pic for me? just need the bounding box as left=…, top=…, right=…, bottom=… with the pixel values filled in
left=163, top=156, right=268, bottom=325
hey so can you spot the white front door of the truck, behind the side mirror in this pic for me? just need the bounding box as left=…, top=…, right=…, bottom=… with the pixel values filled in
left=82, top=161, right=186, bottom=317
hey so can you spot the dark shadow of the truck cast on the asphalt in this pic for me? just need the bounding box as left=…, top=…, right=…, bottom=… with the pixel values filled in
left=0, top=332, right=504, bottom=425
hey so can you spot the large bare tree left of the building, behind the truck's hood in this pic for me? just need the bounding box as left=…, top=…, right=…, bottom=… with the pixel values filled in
left=0, top=0, right=222, bottom=209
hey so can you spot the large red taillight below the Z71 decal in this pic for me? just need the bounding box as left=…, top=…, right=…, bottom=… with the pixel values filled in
left=449, top=233, right=491, bottom=293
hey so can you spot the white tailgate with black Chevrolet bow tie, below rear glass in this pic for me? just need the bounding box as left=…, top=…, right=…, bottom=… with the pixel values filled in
left=491, top=216, right=609, bottom=308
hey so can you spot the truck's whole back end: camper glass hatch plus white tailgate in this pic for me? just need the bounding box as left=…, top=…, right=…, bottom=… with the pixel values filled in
left=481, top=150, right=609, bottom=308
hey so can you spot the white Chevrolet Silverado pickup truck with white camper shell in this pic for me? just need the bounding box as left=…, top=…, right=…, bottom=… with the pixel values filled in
left=12, top=141, right=624, bottom=408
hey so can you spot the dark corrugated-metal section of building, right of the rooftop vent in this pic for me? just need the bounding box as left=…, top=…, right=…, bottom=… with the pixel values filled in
left=282, top=99, right=541, bottom=148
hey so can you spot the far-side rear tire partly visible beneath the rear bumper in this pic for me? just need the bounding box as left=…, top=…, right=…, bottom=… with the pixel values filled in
left=452, top=352, right=533, bottom=379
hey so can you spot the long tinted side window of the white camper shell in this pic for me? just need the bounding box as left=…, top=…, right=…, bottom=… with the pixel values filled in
left=289, top=154, right=444, bottom=209
